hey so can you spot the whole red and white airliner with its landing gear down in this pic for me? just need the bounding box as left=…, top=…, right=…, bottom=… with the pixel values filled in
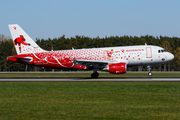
left=7, top=24, right=174, bottom=78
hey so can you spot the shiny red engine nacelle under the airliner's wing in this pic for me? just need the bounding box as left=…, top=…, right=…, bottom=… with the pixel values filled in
left=108, top=63, right=126, bottom=74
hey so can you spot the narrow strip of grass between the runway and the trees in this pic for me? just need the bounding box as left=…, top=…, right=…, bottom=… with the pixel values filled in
left=0, top=72, right=180, bottom=78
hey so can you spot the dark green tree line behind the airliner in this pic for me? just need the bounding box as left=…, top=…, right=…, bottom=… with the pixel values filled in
left=0, top=34, right=180, bottom=71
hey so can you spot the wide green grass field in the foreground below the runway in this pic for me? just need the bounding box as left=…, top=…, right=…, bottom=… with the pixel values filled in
left=0, top=82, right=180, bottom=120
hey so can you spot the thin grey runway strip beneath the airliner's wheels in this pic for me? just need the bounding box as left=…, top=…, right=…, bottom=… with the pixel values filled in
left=0, top=77, right=180, bottom=82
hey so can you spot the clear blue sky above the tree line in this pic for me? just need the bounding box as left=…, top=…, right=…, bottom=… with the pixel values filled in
left=0, top=0, right=180, bottom=40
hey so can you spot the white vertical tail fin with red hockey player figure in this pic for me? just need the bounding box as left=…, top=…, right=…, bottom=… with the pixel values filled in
left=8, top=24, right=44, bottom=54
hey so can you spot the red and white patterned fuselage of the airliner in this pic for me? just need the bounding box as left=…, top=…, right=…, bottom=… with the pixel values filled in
left=8, top=45, right=174, bottom=68
